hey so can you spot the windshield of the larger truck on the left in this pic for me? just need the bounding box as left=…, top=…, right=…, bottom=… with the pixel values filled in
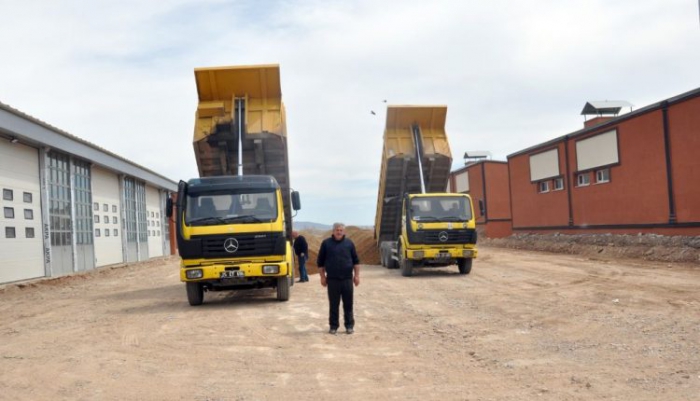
left=185, top=189, right=277, bottom=226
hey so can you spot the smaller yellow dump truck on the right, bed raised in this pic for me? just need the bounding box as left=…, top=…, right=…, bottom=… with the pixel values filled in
left=374, top=106, right=477, bottom=276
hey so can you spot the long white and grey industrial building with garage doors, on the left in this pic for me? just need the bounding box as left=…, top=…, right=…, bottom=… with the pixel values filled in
left=0, top=103, right=177, bottom=284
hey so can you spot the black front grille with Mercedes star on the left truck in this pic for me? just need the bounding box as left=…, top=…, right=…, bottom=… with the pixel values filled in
left=192, top=233, right=286, bottom=258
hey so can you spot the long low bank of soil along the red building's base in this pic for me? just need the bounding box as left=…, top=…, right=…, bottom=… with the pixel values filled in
left=479, top=234, right=700, bottom=264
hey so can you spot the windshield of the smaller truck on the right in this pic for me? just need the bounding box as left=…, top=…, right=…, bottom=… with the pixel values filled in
left=409, top=196, right=472, bottom=221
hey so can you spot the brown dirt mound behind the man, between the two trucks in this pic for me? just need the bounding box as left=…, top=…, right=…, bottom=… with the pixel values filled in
left=295, top=226, right=379, bottom=277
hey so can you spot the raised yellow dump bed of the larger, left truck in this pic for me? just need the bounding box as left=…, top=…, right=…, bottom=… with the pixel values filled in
left=193, top=64, right=292, bottom=236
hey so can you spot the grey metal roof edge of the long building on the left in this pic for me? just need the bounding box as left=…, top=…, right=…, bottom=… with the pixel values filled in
left=0, top=102, right=177, bottom=192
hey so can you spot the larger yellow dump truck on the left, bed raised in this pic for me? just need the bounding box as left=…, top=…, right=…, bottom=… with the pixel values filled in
left=167, top=65, right=300, bottom=305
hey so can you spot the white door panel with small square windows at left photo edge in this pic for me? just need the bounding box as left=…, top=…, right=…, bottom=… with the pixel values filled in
left=0, top=139, right=45, bottom=283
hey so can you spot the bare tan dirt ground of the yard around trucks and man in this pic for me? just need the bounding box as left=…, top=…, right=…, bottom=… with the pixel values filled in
left=0, top=239, right=700, bottom=400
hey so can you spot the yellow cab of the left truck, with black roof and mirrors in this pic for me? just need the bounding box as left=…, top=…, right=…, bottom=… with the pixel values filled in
left=168, top=175, right=299, bottom=305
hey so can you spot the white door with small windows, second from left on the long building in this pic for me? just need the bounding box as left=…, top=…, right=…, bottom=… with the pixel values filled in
left=92, top=166, right=124, bottom=267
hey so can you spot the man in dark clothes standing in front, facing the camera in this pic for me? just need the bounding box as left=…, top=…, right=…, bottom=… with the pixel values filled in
left=316, top=223, right=360, bottom=334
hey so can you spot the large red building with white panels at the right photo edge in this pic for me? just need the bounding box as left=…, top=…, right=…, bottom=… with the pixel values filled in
left=506, top=88, right=700, bottom=235
